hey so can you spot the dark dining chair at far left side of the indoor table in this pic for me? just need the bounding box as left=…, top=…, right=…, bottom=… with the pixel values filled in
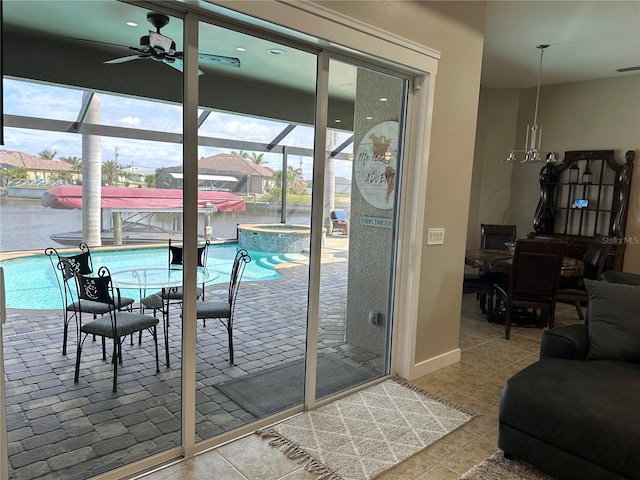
left=462, top=223, right=517, bottom=321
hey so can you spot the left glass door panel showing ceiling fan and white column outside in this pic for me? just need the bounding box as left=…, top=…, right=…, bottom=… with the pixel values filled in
left=0, top=1, right=183, bottom=479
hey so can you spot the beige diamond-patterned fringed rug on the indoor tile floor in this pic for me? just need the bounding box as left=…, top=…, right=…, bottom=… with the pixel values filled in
left=256, top=380, right=475, bottom=480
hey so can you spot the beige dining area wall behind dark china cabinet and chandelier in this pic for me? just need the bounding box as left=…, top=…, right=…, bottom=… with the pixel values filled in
left=476, top=74, right=640, bottom=273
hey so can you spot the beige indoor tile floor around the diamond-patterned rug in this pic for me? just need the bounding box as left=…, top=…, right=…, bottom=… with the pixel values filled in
left=141, top=295, right=579, bottom=480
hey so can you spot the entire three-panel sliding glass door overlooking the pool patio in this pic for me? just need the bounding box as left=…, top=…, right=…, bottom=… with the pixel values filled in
left=0, top=0, right=407, bottom=479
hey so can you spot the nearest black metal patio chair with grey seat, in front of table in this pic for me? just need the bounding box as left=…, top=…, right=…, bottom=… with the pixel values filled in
left=74, top=266, right=160, bottom=392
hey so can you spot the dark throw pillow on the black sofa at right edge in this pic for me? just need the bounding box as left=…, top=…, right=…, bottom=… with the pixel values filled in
left=584, top=279, right=640, bottom=363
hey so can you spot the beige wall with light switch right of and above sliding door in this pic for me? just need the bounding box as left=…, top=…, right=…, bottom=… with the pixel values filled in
left=318, top=1, right=485, bottom=368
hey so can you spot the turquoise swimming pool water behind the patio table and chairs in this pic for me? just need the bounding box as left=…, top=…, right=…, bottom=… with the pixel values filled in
left=0, top=244, right=306, bottom=310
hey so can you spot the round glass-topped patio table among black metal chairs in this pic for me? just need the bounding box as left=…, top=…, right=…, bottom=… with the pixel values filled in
left=111, top=265, right=220, bottom=367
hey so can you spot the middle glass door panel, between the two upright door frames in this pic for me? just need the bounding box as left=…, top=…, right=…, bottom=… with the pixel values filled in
left=195, top=23, right=316, bottom=441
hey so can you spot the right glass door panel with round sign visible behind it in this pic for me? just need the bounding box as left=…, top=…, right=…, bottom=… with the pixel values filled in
left=316, top=60, right=406, bottom=399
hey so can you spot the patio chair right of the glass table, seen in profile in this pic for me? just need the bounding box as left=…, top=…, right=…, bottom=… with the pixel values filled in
left=196, top=248, right=251, bottom=364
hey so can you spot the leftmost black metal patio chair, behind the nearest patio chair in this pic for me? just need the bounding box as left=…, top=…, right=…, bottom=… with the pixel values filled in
left=44, top=246, right=134, bottom=355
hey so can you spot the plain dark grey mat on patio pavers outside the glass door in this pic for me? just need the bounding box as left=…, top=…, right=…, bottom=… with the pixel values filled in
left=215, top=354, right=374, bottom=418
